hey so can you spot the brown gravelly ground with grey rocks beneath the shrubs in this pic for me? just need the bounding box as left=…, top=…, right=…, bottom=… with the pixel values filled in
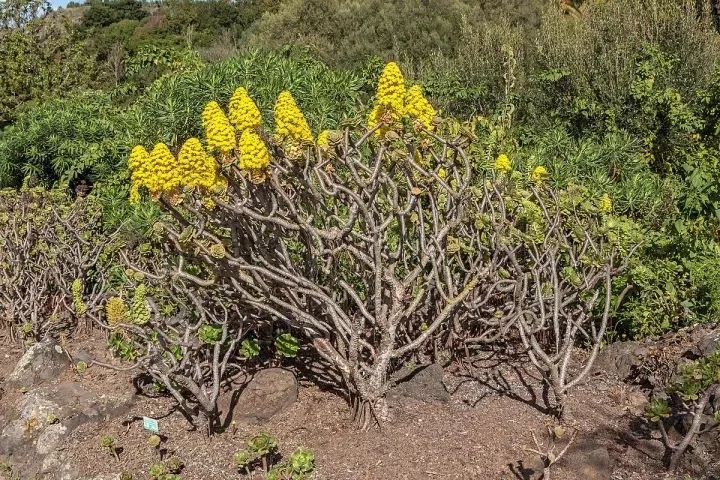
left=0, top=329, right=720, bottom=480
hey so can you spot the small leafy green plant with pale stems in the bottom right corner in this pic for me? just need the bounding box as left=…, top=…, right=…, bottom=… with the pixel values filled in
left=645, top=351, right=720, bottom=471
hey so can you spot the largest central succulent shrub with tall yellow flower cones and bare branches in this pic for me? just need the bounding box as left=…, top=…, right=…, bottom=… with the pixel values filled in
left=124, top=64, right=476, bottom=424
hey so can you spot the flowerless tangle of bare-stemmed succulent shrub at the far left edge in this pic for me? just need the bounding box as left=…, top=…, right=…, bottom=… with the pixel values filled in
left=0, top=188, right=114, bottom=339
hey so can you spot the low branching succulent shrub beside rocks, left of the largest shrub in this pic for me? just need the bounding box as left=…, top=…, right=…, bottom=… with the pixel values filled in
left=97, top=266, right=261, bottom=431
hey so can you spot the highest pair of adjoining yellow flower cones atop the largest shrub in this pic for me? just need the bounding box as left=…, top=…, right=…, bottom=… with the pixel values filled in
left=368, top=62, right=437, bottom=136
